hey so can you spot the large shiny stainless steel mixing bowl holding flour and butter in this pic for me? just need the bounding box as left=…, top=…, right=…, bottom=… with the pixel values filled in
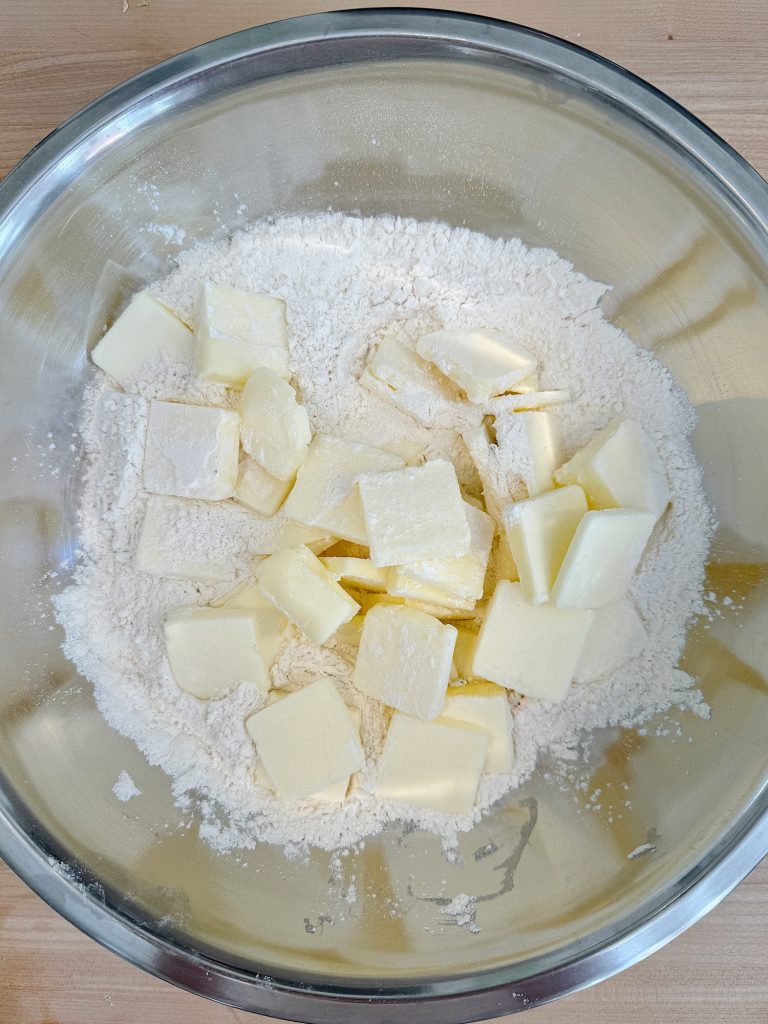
left=0, top=10, right=768, bottom=1024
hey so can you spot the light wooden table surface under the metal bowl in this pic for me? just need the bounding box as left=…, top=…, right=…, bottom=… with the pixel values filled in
left=0, top=0, right=768, bottom=1024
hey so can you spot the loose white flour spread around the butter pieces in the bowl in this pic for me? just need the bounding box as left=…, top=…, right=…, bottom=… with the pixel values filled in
left=56, top=215, right=711, bottom=851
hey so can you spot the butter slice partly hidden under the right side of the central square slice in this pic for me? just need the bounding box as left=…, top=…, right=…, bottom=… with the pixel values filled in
left=390, top=502, right=495, bottom=606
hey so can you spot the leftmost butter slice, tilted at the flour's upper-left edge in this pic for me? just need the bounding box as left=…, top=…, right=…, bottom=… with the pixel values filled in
left=91, top=292, right=194, bottom=384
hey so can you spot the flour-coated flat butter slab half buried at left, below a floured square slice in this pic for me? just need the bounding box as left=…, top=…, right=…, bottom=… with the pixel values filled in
left=136, top=495, right=258, bottom=583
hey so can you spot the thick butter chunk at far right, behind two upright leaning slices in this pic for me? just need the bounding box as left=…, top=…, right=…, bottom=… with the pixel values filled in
left=555, top=419, right=670, bottom=518
